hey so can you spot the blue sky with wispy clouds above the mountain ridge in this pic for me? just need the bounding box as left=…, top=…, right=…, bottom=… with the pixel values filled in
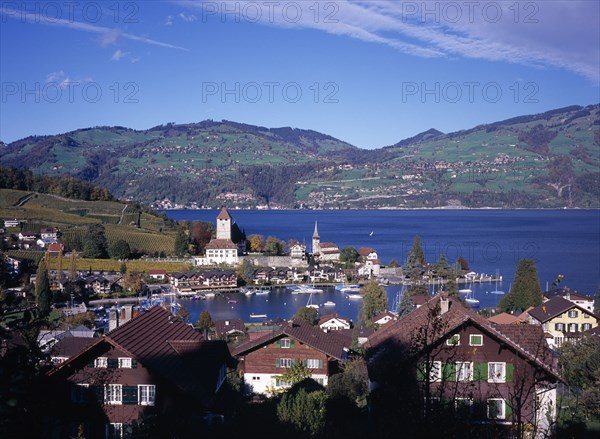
left=0, top=0, right=600, bottom=148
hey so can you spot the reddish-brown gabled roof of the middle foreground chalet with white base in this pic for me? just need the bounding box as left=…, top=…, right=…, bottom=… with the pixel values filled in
left=231, top=320, right=350, bottom=361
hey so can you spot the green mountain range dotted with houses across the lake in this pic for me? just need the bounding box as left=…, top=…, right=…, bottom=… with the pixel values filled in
left=0, top=105, right=600, bottom=209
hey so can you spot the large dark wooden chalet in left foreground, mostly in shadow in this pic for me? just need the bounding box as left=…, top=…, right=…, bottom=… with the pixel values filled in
left=46, top=307, right=235, bottom=437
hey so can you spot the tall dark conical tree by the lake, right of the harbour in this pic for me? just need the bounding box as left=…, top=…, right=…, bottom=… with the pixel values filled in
left=498, top=259, right=543, bottom=312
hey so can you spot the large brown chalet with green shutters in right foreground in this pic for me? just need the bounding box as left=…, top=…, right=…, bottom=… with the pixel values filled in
left=365, top=294, right=561, bottom=437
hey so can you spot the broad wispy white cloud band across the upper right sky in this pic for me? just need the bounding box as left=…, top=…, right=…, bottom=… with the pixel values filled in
left=178, top=0, right=600, bottom=83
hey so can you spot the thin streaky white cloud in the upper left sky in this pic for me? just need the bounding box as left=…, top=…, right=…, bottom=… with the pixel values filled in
left=0, top=5, right=188, bottom=51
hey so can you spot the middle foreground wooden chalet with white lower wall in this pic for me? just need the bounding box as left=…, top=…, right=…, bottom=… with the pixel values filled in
left=232, top=320, right=349, bottom=394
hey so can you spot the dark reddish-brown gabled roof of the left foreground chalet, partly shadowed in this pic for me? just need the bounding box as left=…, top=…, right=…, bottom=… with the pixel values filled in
left=50, top=306, right=235, bottom=403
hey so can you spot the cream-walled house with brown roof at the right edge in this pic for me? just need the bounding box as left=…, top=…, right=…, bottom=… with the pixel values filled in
left=526, top=296, right=598, bottom=348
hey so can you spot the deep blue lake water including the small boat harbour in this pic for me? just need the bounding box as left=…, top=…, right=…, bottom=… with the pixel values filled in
left=166, top=210, right=600, bottom=321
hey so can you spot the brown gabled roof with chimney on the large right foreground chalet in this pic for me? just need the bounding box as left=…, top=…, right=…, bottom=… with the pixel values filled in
left=365, top=294, right=561, bottom=379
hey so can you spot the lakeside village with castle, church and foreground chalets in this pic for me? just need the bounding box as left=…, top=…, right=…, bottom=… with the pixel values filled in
left=2, top=208, right=600, bottom=438
